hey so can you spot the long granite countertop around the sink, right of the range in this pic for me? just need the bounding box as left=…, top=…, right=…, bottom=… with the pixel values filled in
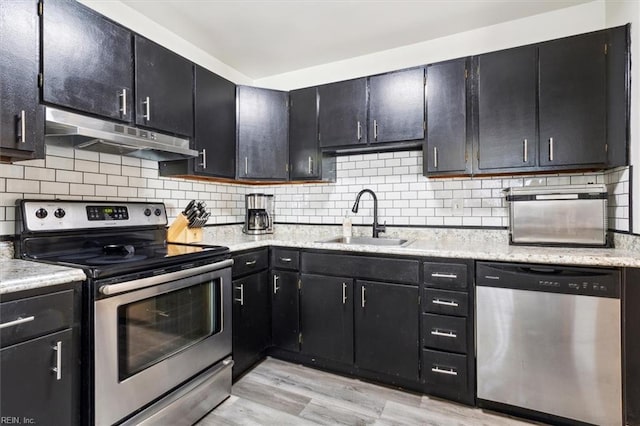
left=203, top=231, right=640, bottom=267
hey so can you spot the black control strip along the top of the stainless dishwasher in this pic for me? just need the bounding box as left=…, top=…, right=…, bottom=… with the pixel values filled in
left=476, top=262, right=620, bottom=298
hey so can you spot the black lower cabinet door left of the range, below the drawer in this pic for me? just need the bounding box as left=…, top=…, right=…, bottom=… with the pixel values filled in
left=0, top=329, right=79, bottom=425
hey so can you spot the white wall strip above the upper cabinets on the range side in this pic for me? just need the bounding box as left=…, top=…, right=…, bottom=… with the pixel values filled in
left=78, top=0, right=253, bottom=84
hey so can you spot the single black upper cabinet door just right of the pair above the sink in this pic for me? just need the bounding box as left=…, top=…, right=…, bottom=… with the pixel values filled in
left=423, top=59, right=468, bottom=174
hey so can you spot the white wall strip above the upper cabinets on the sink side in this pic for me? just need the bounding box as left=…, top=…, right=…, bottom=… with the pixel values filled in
left=254, top=0, right=604, bottom=90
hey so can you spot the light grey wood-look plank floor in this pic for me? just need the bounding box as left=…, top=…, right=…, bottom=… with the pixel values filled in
left=197, top=358, right=532, bottom=426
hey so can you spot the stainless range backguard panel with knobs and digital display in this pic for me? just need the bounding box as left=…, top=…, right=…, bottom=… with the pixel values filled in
left=18, top=200, right=167, bottom=231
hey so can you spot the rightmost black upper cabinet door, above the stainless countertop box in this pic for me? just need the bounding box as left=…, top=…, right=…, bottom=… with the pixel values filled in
left=539, top=32, right=607, bottom=166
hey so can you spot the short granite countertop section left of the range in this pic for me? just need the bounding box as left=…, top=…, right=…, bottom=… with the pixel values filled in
left=0, top=259, right=87, bottom=295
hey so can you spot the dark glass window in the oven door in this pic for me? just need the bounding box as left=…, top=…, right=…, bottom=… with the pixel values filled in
left=118, top=279, right=222, bottom=381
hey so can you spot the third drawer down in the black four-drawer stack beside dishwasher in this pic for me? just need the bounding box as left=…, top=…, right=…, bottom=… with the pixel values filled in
left=422, top=314, right=467, bottom=353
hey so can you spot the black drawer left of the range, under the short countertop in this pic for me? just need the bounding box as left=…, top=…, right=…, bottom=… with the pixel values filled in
left=0, top=290, right=73, bottom=347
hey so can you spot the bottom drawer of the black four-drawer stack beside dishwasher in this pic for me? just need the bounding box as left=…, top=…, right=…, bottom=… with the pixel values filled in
left=422, top=349, right=467, bottom=394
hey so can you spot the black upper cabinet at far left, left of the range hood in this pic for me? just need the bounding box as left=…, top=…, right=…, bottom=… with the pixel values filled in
left=0, top=0, right=44, bottom=160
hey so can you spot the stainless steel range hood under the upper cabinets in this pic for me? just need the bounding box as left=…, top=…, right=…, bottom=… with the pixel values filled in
left=45, top=107, right=198, bottom=161
